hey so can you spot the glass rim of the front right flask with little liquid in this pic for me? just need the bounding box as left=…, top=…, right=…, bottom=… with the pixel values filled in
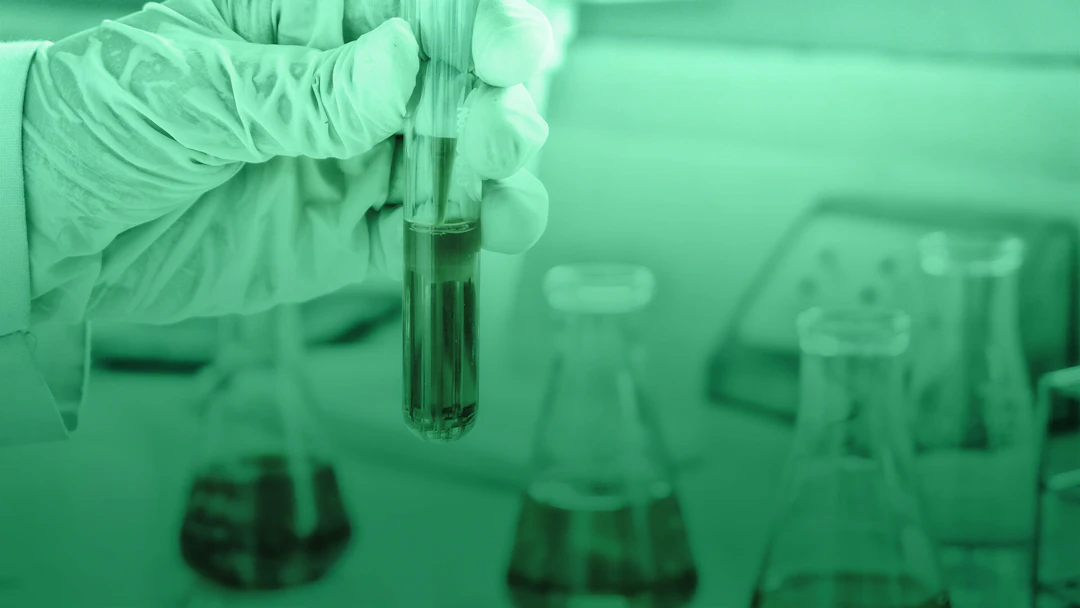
left=796, top=308, right=912, bottom=356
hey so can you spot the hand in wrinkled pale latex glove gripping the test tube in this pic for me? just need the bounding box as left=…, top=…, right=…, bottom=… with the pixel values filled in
left=24, top=0, right=552, bottom=323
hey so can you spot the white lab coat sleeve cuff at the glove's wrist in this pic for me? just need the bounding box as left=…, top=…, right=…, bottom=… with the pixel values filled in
left=0, top=42, right=89, bottom=446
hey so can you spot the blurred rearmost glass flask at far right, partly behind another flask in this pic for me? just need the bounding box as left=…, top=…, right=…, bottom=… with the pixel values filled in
left=913, top=232, right=1042, bottom=608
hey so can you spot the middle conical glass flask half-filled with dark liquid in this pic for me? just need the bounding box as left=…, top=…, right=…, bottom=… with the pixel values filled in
left=508, top=265, right=698, bottom=608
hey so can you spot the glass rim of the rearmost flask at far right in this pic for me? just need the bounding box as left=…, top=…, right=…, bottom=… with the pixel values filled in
left=919, top=231, right=1024, bottom=276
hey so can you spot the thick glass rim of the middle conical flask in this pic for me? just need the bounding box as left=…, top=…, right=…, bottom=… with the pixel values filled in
left=543, top=264, right=656, bottom=314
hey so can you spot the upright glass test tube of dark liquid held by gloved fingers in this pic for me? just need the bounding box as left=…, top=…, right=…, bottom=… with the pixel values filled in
left=403, top=0, right=481, bottom=441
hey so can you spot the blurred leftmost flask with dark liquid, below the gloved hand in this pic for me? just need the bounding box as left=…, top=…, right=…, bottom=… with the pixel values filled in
left=180, top=307, right=353, bottom=592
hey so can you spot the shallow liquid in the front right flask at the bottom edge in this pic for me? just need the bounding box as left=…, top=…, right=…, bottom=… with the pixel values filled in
left=751, top=572, right=949, bottom=608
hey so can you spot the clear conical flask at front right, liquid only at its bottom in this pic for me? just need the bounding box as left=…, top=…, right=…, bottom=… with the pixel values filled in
left=753, top=309, right=948, bottom=608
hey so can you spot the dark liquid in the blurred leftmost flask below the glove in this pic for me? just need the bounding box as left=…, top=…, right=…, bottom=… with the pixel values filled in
left=180, top=456, right=352, bottom=590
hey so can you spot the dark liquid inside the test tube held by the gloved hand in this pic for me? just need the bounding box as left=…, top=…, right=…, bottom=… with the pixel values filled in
left=404, top=224, right=480, bottom=441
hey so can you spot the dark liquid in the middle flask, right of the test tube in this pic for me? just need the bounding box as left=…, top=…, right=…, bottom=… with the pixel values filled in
left=507, top=485, right=698, bottom=608
